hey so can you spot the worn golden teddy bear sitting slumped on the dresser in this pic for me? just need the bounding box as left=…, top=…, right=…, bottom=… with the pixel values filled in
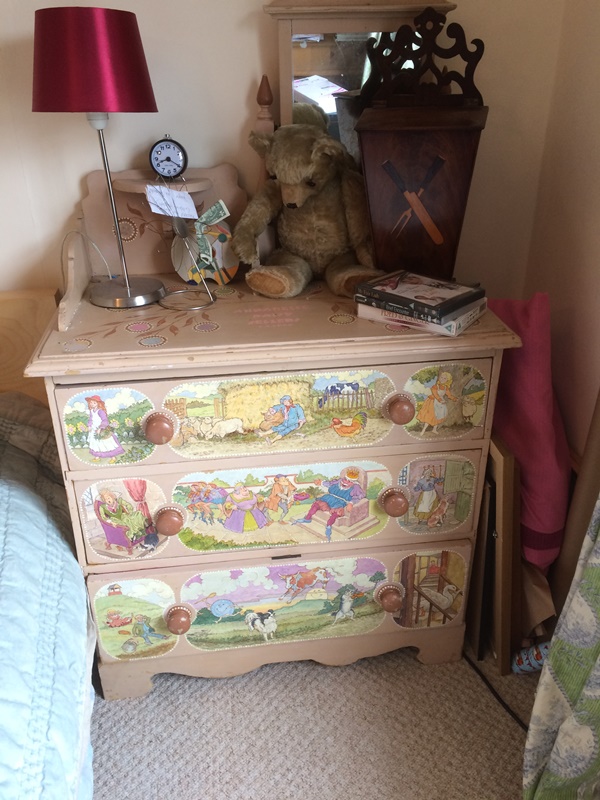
left=232, top=123, right=382, bottom=298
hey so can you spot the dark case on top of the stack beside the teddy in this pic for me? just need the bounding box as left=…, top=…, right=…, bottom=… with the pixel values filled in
left=354, top=270, right=485, bottom=322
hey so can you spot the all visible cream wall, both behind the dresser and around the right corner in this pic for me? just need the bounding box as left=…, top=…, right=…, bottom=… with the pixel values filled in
left=0, top=0, right=600, bottom=452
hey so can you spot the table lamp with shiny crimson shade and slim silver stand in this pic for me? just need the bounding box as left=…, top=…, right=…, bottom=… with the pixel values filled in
left=33, top=6, right=165, bottom=308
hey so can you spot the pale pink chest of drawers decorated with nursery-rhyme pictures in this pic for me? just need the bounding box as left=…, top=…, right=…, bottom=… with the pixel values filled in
left=27, top=278, right=520, bottom=698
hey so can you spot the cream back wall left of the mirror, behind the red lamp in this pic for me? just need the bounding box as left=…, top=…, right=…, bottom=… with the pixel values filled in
left=0, top=0, right=277, bottom=290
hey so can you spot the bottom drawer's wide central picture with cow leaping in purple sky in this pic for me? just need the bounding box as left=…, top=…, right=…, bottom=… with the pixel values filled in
left=181, top=557, right=388, bottom=650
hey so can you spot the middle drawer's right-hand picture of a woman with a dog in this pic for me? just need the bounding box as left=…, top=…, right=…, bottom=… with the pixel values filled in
left=398, top=452, right=477, bottom=535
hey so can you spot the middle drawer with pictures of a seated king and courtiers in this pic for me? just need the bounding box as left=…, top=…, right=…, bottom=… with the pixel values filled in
left=68, top=442, right=487, bottom=565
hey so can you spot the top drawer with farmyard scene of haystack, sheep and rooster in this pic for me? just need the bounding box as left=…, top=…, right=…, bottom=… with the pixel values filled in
left=55, top=358, right=492, bottom=470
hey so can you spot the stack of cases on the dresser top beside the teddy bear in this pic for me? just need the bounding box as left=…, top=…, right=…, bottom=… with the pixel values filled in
left=354, top=270, right=487, bottom=336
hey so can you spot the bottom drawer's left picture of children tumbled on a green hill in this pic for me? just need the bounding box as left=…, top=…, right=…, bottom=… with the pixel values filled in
left=94, top=577, right=178, bottom=661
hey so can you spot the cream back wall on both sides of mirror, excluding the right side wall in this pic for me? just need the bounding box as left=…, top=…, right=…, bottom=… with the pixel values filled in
left=0, top=0, right=560, bottom=296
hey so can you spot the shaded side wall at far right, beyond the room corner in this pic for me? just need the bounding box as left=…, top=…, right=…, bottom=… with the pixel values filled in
left=525, top=0, right=600, bottom=457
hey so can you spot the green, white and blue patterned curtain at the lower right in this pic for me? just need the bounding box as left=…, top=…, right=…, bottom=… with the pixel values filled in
left=523, top=490, right=600, bottom=800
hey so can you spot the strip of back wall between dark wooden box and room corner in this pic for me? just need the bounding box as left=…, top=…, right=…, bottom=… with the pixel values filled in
left=450, top=0, right=564, bottom=297
